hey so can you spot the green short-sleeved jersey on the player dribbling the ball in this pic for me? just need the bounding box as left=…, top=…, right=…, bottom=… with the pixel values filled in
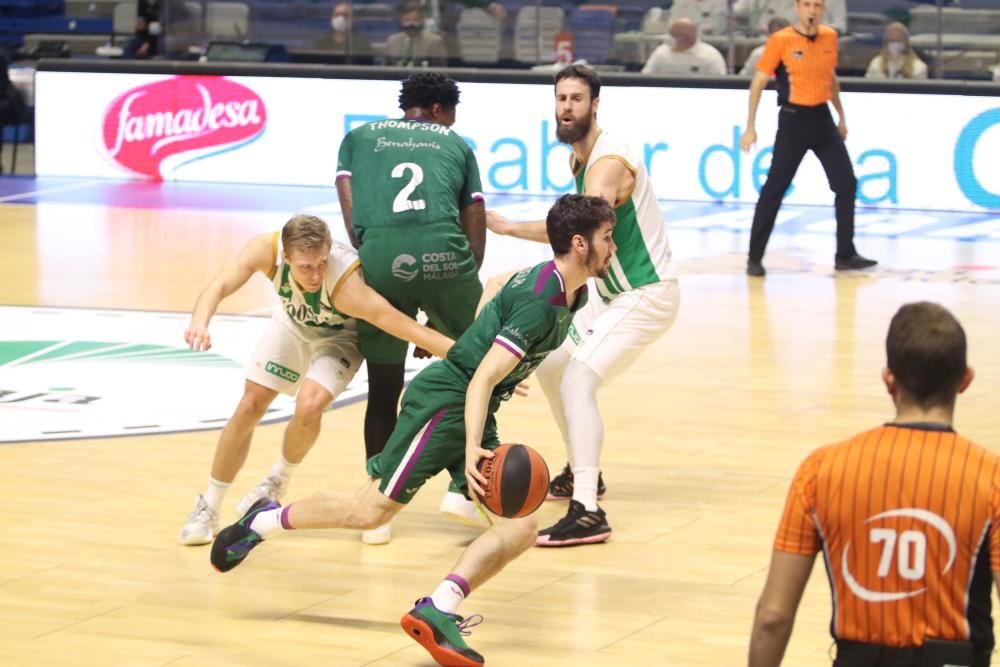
left=439, top=261, right=587, bottom=412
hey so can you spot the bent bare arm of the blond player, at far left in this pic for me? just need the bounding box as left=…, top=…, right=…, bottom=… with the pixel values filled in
left=184, top=234, right=277, bottom=351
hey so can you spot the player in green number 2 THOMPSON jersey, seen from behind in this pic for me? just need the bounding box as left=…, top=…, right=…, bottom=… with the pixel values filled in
left=337, top=72, right=486, bottom=544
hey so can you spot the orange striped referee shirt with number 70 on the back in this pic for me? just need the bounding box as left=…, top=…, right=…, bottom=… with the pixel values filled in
left=774, top=424, right=1000, bottom=647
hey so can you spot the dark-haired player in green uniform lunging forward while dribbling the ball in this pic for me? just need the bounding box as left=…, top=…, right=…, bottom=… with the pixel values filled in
left=212, top=195, right=615, bottom=667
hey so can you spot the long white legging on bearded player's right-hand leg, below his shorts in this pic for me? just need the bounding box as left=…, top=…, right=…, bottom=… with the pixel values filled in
left=560, top=366, right=604, bottom=512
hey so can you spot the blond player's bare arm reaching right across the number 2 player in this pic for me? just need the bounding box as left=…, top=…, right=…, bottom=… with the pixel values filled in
left=333, top=269, right=454, bottom=358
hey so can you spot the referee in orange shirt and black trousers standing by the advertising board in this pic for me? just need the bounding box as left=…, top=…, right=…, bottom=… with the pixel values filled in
left=740, top=0, right=877, bottom=276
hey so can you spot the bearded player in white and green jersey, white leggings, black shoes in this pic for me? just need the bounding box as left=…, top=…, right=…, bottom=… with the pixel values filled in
left=487, top=65, right=680, bottom=547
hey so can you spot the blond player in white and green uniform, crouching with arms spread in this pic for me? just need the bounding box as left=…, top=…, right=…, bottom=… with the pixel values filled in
left=181, top=215, right=452, bottom=545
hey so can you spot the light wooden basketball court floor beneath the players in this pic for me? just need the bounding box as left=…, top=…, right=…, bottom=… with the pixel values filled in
left=0, top=179, right=1000, bottom=667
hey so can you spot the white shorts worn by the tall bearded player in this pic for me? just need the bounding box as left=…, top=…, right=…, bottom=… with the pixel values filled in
left=563, top=280, right=681, bottom=382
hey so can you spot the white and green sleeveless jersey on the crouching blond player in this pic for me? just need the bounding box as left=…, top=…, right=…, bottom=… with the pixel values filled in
left=270, top=232, right=361, bottom=333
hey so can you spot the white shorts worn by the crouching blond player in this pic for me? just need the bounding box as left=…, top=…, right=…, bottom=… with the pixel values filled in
left=246, top=313, right=362, bottom=398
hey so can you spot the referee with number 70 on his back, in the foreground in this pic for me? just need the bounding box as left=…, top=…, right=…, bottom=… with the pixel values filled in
left=750, top=302, right=1000, bottom=667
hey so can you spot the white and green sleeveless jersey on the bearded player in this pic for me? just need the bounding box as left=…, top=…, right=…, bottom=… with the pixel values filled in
left=573, top=132, right=677, bottom=300
